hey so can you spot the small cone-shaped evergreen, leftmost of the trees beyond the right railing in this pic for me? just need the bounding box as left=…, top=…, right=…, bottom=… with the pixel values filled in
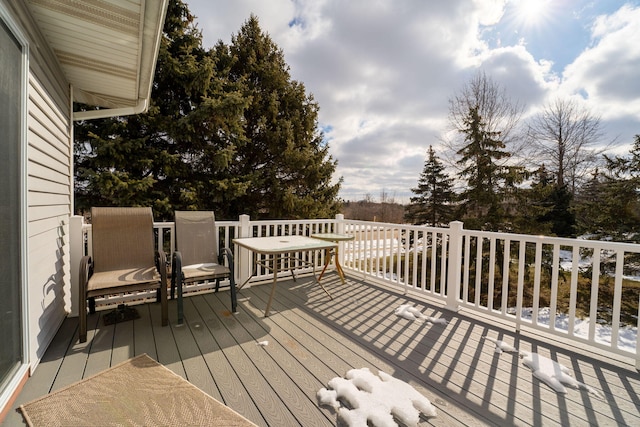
left=405, top=146, right=455, bottom=227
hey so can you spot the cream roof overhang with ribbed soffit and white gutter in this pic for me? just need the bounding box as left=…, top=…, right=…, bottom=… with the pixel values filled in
left=27, top=0, right=169, bottom=120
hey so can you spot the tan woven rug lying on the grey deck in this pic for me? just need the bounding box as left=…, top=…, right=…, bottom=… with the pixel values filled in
left=20, top=354, right=255, bottom=427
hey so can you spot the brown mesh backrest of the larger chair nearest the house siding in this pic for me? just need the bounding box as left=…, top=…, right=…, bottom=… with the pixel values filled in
left=91, top=207, right=155, bottom=272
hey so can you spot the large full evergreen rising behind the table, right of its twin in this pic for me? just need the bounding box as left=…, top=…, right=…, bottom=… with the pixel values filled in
left=216, top=16, right=340, bottom=218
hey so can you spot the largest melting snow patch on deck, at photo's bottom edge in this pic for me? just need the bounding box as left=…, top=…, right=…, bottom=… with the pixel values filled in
left=317, top=368, right=437, bottom=427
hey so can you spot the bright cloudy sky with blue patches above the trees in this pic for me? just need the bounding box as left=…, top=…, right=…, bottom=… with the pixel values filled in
left=185, top=0, right=640, bottom=203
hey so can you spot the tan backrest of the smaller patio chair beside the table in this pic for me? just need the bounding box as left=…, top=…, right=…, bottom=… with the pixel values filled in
left=175, top=211, right=218, bottom=265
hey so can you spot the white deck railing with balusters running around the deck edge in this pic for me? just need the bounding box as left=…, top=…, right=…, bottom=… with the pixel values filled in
left=71, top=215, right=640, bottom=368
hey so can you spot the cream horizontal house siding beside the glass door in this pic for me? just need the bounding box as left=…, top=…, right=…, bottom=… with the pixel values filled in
left=5, top=1, right=73, bottom=371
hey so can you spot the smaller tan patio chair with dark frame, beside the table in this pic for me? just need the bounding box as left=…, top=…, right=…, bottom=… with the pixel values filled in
left=171, top=211, right=238, bottom=324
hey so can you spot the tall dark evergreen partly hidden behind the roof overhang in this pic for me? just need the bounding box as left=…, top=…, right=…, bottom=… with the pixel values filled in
left=75, top=1, right=221, bottom=220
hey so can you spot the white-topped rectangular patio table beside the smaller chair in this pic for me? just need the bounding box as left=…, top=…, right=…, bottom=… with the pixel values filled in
left=233, top=236, right=338, bottom=317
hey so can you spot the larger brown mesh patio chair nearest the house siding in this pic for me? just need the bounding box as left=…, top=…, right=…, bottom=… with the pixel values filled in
left=79, top=207, right=169, bottom=342
